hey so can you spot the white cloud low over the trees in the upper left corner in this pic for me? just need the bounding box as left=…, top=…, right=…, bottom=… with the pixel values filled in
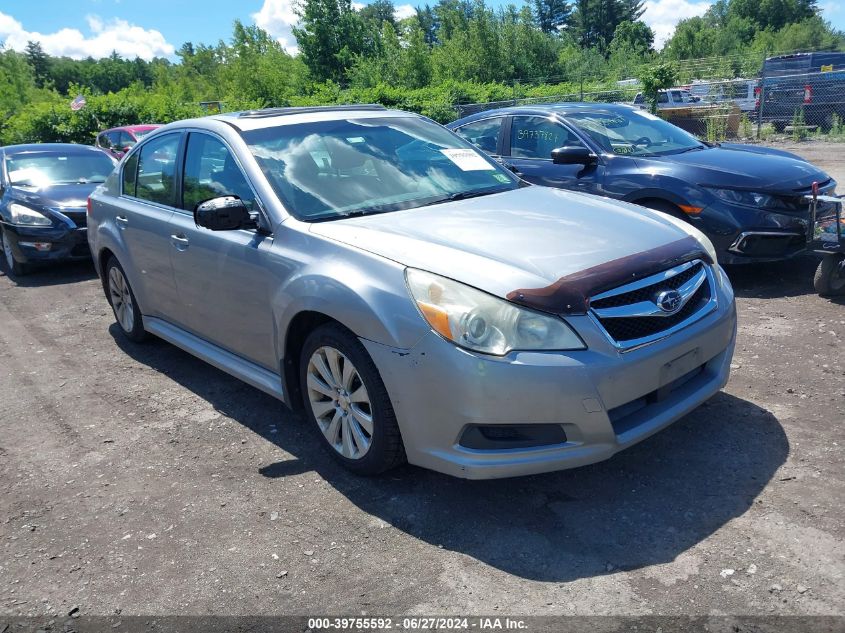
left=0, top=12, right=174, bottom=60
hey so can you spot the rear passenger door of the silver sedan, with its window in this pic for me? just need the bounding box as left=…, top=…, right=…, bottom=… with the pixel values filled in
left=115, top=132, right=182, bottom=320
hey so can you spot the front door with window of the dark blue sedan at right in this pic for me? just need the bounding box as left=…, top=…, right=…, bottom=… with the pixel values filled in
left=503, top=115, right=604, bottom=193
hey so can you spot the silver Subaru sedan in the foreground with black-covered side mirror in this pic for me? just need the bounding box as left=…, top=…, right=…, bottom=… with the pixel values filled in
left=88, top=106, right=736, bottom=478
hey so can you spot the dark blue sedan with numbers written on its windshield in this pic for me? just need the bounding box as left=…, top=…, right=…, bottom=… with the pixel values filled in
left=448, top=103, right=836, bottom=264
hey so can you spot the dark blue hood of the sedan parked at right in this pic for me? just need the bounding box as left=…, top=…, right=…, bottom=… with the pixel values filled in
left=636, top=145, right=830, bottom=193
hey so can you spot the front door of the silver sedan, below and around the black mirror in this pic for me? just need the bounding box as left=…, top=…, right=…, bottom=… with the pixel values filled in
left=169, top=131, right=279, bottom=372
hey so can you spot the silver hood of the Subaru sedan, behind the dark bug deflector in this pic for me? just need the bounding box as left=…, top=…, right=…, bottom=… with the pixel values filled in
left=311, top=187, right=701, bottom=311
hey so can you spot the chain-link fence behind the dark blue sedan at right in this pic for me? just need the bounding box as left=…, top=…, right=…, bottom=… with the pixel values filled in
left=454, top=51, right=845, bottom=142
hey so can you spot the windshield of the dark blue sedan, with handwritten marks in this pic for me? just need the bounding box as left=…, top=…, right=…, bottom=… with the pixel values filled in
left=567, top=110, right=706, bottom=156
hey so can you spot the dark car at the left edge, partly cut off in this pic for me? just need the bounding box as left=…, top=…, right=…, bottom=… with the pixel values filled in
left=0, top=143, right=117, bottom=276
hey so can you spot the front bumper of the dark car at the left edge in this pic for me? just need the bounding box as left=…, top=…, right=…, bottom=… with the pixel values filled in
left=3, top=224, right=91, bottom=264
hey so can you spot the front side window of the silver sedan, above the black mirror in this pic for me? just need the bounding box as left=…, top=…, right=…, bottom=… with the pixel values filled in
left=181, top=132, right=255, bottom=211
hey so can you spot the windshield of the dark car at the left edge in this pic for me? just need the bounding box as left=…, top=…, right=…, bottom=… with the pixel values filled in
left=6, top=152, right=114, bottom=187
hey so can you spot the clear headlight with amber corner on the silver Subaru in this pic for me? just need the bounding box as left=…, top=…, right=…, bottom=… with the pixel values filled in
left=405, top=268, right=586, bottom=356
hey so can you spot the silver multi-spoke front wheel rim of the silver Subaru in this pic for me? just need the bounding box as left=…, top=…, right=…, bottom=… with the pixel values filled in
left=306, top=346, right=373, bottom=459
